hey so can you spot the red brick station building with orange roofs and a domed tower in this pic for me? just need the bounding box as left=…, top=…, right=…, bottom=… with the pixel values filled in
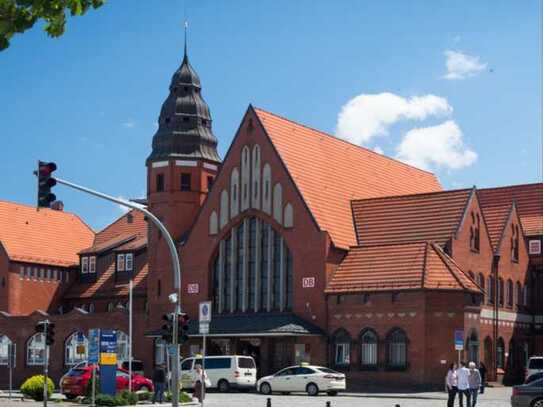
left=0, top=46, right=543, bottom=387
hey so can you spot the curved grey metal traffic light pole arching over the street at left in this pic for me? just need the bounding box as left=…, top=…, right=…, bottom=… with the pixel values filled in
left=50, top=177, right=181, bottom=407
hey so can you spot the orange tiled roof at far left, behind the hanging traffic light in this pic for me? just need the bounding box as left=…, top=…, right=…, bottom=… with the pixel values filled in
left=0, top=201, right=94, bottom=267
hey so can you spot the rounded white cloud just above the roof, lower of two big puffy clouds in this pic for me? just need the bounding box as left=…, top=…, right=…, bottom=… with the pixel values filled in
left=396, top=120, right=477, bottom=169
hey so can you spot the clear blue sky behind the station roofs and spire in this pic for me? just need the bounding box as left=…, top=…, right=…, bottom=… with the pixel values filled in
left=0, top=0, right=543, bottom=228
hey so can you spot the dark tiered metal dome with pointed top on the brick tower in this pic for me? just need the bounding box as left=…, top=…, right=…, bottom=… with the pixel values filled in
left=147, top=48, right=221, bottom=163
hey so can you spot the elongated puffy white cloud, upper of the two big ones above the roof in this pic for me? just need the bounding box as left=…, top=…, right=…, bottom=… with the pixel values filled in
left=336, top=92, right=453, bottom=145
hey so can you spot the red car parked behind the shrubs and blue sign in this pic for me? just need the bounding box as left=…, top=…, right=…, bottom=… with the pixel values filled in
left=60, top=365, right=154, bottom=399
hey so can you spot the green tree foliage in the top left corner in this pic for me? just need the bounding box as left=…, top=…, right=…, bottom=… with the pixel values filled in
left=0, top=0, right=105, bottom=51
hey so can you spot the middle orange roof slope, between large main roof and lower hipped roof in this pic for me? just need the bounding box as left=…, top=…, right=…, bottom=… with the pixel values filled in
left=352, top=189, right=473, bottom=246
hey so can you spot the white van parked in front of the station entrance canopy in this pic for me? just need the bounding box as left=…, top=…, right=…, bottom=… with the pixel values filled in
left=181, top=355, right=256, bottom=392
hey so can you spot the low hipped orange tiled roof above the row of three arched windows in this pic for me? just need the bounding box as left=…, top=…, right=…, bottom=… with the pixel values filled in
left=326, top=242, right=481, bottom=294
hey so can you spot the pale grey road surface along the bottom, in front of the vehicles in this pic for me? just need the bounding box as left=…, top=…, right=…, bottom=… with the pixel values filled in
left=0, top=387, right=511, bottom=407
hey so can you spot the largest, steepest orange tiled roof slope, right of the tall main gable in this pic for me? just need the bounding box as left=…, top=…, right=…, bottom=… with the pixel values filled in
left=255, top=109, right=442, bottom=248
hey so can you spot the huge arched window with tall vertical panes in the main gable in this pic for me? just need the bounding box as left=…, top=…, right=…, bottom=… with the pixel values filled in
left=212, top=217, right=293, bottom=313
